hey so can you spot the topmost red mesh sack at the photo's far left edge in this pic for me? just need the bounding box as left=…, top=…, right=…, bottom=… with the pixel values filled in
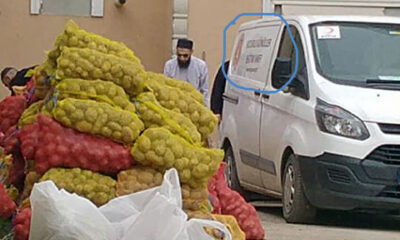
left=0, top=96, right=26, bottom=133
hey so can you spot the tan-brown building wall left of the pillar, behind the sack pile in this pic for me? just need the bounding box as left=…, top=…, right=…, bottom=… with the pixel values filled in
left=0, top=0, right=172, bottom=99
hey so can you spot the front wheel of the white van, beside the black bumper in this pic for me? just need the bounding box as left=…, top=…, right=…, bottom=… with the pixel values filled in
left=282, top=154, right=317, bottom=223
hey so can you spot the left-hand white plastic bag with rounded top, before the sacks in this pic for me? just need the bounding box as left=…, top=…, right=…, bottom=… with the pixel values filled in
left=29, top=181, right=117, bottom=240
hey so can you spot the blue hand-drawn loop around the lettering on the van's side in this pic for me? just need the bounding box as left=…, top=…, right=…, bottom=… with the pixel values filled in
left=221, top=13, right=299, bottom=94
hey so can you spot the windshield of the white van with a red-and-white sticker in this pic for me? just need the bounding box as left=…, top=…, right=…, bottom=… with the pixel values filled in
left=311, top=22, right=400, bottom=89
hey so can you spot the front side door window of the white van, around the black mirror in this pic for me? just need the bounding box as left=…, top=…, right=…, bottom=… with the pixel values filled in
left=272, top=26, right=309, bottom=99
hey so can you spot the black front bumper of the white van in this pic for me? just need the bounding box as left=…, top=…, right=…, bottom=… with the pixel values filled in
left=298, top=153, right=400, bottom=210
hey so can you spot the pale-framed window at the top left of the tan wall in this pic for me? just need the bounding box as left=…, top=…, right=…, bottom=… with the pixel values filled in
left=31, top=0, right=104, bottom=17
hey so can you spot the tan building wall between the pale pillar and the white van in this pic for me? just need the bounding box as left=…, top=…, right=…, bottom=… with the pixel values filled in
left=188, top=0, right=262, bottom=90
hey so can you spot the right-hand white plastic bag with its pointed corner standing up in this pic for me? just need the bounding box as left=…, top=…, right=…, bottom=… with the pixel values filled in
left=100, top=169, right=187, bottom=240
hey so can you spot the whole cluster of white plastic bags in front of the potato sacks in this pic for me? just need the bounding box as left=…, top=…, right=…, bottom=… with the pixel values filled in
left=29, top=169, right=231, bottom=240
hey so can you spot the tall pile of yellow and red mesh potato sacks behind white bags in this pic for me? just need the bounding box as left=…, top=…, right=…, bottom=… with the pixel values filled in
left=0, top=21, right=264, bottom=240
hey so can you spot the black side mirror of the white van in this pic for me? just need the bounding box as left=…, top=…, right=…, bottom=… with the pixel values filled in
left=272, top=57, right=292, bottom=88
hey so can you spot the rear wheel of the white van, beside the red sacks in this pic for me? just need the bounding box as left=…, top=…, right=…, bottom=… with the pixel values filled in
left=224, top=146, right=247, bottom=199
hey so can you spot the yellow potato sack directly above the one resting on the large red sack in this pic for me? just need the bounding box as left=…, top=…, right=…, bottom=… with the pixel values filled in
left=56, top=78, right=135, bottom=112
